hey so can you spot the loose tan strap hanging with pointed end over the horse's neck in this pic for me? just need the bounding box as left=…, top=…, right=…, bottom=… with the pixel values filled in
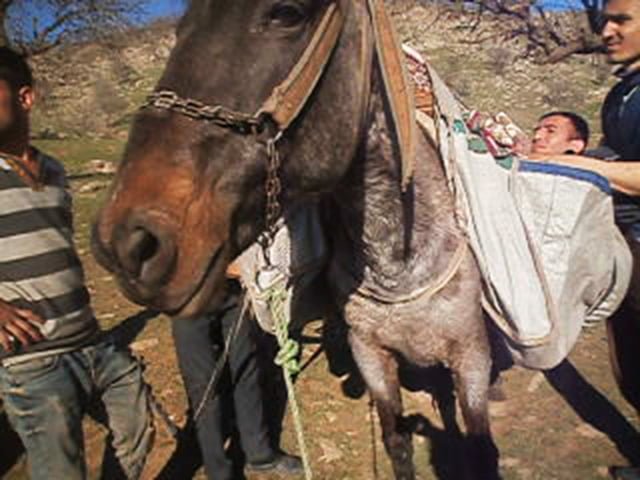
left=367, top=0, right=417, bottom=190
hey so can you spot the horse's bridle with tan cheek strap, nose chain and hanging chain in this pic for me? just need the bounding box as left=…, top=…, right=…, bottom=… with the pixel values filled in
left=142, top=2, right=345, bottom=237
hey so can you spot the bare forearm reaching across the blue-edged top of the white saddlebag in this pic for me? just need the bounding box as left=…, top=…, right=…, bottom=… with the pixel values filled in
left=532, top=155, right=640, bottom=196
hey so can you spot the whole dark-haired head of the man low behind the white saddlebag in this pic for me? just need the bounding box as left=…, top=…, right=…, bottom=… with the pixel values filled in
left=531, top=112, right=592, bottom=155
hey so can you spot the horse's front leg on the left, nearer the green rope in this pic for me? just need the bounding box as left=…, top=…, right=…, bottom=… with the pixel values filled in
left=349, top=332, right=415, bottom=480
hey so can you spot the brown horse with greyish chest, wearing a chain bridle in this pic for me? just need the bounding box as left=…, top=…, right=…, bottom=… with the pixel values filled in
left=92, top=0, right=498, bottom=480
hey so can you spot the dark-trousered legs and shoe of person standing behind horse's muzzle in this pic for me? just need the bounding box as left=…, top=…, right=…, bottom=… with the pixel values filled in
left=172, top=280, right=303, bottom=480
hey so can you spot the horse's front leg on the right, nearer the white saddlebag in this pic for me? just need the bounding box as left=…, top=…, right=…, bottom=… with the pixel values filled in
left=452, top=349, right=500, bottom=480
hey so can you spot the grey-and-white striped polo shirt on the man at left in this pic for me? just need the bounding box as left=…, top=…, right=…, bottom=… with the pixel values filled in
left=0, top=152, right=98, bottom=365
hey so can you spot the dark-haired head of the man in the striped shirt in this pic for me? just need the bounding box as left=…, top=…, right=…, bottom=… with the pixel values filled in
left=0, top=47, right=35, bottom=142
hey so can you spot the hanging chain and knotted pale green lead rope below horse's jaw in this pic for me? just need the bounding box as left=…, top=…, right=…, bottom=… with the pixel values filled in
left=262, top=132, right=313, bottom=480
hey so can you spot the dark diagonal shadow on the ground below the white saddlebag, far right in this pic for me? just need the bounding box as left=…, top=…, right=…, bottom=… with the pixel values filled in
left=545, top=360, right=640, bottom=465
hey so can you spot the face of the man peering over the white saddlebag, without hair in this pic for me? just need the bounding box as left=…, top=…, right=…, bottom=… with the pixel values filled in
left=531, top=115, right=586, bottom=155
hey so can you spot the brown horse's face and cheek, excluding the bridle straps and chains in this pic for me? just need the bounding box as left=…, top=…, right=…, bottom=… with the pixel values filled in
left=93, top=0, right=364, bottom=316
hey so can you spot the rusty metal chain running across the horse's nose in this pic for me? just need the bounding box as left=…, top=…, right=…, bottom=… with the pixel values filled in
left=142, top=90, right=264, bottom=135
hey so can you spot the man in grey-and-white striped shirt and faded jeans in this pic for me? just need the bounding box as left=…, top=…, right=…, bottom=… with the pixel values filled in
left=0, top=47, right=153, bottom=480
